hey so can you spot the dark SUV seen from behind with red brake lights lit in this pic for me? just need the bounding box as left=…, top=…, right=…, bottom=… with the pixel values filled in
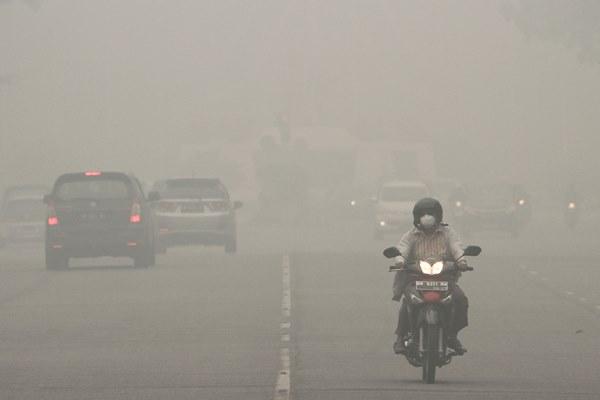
left=44, top=171, right=157, bottom=269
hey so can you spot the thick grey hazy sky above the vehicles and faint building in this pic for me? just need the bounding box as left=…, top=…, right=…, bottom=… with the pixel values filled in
left=0, top=0, right=600, bottom=190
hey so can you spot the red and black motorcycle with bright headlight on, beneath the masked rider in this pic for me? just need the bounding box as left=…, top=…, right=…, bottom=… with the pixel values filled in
left=383, top=246, right=481, bottom=383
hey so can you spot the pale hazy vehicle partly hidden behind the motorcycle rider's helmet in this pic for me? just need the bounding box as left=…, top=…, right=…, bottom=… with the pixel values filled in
left=375, top=181, right=429, bottom=239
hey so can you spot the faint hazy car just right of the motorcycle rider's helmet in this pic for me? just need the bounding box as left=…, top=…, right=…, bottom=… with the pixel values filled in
left=450, top=183, right=532, bottom=236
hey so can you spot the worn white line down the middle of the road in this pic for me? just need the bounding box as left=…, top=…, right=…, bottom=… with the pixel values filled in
left=273, top=254, right=292, bottom=400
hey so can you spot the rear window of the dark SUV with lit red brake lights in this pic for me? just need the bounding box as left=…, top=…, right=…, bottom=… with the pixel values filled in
left=56, top=178, right=131, bottom=201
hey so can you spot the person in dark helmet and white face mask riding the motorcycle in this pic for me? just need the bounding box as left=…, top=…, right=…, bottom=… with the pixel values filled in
left=393, top=198, right=469, bottom=354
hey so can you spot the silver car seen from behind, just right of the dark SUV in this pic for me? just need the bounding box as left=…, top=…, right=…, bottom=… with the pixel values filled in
left=153, top=178, right=242, bottom=253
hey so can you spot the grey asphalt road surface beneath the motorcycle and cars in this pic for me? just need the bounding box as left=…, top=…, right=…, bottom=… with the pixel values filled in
left=0, top=220, right=600, bottom=400
